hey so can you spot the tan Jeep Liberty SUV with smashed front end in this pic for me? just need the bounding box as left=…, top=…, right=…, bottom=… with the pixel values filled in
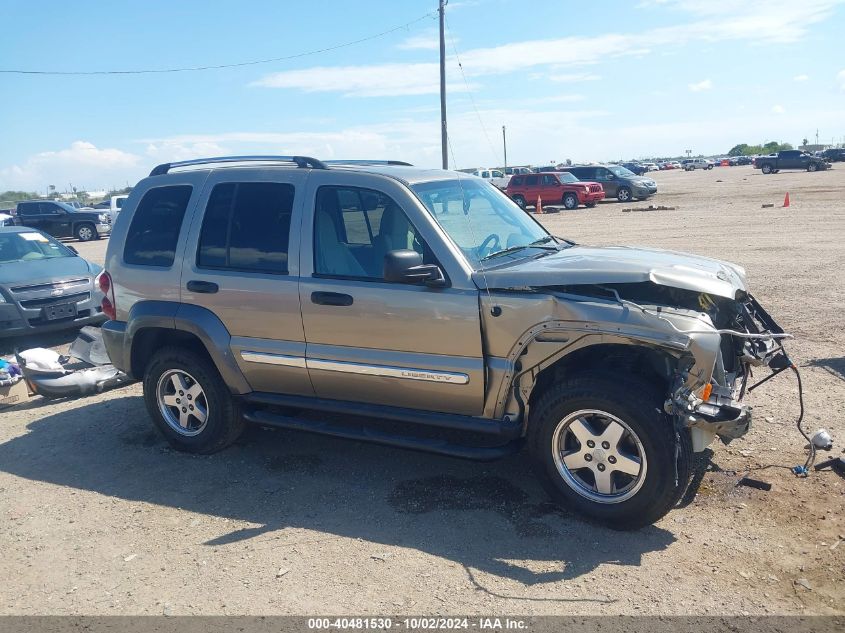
left=98, top=156, right=788, bottom=529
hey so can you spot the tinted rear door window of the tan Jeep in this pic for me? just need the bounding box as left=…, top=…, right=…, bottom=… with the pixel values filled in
left=197, top=182, right=294, bottom=274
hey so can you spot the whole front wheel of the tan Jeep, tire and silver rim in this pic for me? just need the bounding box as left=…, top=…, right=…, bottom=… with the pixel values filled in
left=528, top=373, right=692, bottom=530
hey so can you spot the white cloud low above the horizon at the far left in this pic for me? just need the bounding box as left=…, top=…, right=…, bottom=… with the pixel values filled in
left=0, top=141, right=141, bottom=191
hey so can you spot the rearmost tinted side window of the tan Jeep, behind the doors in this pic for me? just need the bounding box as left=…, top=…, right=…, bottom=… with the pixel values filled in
left=123, top=185, right=193, bottom=267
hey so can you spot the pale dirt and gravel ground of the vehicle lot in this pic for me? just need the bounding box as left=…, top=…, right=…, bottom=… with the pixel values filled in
left=0, top=165, right=845, bottom=615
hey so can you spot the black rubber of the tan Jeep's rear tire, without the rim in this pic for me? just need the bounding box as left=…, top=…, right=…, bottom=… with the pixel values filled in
left=143, top=347, right=246, bottom=454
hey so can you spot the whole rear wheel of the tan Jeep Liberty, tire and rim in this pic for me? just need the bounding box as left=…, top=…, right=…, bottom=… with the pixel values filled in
left=144, top=347, right=246, bottom=454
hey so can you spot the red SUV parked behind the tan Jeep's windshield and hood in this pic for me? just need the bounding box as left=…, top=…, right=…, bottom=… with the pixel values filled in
left=507, top=171, right=604, bottom=209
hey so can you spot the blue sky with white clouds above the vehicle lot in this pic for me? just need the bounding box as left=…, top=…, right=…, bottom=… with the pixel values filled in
left=0, top=0, right=845, bottom=191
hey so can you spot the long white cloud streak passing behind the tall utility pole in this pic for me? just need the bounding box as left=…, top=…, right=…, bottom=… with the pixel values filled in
left=252, top=0, right=845, bottom=97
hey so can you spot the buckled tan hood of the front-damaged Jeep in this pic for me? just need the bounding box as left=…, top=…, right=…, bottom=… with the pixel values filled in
left=473, top=245, right=746, bottom=299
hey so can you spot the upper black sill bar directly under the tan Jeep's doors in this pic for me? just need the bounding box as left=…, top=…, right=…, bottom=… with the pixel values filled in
left=240, top=391, right=522, bottom=440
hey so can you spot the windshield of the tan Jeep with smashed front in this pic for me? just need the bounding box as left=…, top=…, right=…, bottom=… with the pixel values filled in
left=411, top=178, right=554, bottom=269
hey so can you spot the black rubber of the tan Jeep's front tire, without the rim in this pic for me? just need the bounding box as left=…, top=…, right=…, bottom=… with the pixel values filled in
left=528, top=372, right=692, bottom=530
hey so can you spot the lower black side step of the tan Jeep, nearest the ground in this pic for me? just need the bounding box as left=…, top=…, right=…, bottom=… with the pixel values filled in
left=244, top=409, right=523, bottom=461
